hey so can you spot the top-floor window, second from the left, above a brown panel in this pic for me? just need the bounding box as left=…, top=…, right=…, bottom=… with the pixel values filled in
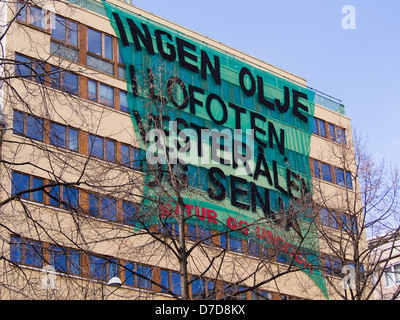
left=50, top=16, right=79, bottom=62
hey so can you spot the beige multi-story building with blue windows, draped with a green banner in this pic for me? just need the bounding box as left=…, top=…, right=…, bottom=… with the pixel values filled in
left=1, top=0, right=368, bottom=299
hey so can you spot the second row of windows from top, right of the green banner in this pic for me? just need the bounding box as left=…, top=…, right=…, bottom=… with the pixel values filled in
left=311, top=159, right=353, bottom=189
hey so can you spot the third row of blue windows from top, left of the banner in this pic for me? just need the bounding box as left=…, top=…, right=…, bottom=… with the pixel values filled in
left=13, top=110, right=144, bottom=170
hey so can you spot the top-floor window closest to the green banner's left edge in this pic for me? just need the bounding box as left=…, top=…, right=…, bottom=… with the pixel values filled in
left=86, top=28, right=114, bottom=75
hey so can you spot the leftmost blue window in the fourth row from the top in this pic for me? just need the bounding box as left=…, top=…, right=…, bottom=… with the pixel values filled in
left=11, top=171, right=43, bottom=202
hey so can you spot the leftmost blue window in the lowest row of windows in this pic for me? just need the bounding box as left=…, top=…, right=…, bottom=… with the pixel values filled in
left=10, top=236, right=43, bottom=268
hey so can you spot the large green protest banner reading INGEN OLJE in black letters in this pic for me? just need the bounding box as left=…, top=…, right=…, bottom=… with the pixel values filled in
left=103, top=2, right=328, bottom=296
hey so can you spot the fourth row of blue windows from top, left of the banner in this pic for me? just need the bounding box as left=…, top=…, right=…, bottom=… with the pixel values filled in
left=11, top=171, right=136, bottom=225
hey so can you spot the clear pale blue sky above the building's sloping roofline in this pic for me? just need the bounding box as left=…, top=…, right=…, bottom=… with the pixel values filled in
left=133, top=0, right=400, bottom=167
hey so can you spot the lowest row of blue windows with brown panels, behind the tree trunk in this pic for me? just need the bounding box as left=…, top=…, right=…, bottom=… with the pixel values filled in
left=10, top=236, right=280, bottom=300
